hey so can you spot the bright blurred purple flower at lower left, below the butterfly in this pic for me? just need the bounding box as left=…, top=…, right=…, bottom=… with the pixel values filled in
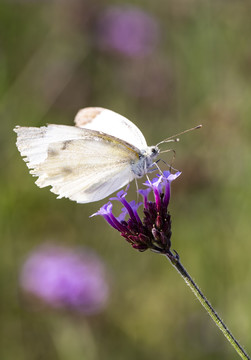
left=20, top=244, right=109, bottom=314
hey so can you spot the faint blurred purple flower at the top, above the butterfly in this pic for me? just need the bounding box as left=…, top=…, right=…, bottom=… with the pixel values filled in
left=97, top=6, right=159, bottom=57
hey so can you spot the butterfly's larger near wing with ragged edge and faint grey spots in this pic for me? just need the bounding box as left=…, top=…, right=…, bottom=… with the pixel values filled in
left=14, top=125, right=139, bottom=203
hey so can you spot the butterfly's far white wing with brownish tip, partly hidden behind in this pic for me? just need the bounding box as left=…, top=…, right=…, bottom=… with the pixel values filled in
left=74, top=107, right=147, bottom=150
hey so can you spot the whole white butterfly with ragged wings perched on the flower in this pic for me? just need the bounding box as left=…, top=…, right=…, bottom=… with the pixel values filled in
left=14, top=107, right=160, bottom=203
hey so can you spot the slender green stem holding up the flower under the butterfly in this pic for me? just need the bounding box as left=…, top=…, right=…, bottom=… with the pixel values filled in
left=165, top=250, right=250, bottom=360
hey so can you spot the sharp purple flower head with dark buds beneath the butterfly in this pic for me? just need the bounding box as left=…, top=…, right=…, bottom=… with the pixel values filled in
left=92, top=171, right=181, bottom=253
